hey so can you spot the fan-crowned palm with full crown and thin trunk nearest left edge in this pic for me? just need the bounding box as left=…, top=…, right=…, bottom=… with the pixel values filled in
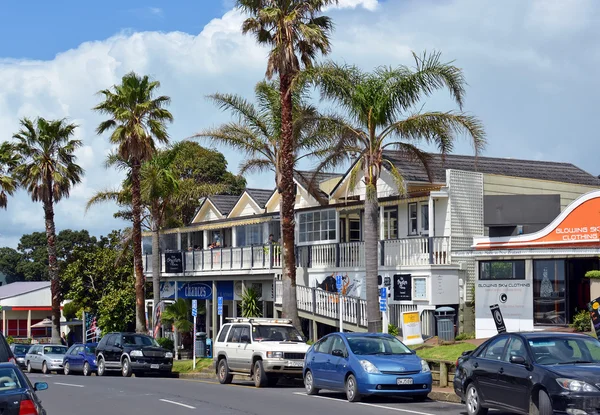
left=13, top=118, right=84, bottom=342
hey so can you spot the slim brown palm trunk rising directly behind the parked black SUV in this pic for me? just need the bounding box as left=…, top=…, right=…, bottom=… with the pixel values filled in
left=131, top=160, right=147, bottom=333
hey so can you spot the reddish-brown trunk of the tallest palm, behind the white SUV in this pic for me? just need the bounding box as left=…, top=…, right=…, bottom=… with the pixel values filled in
left=277, top=73, right=302, bottom=333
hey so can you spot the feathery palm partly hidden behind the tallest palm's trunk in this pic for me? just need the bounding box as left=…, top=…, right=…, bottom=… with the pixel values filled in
left=194, top=81, right=332, bottom=327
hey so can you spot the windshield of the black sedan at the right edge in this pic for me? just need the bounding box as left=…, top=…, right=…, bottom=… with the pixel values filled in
left=528, top=337, right=600, bottom=365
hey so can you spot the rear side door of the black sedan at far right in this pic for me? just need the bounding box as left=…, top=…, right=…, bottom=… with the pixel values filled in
left=472, top=336, right=508, bottom=402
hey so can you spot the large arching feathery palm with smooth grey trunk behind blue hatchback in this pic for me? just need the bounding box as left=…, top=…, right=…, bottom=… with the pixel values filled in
left=309, top=53, right=485, bottom=332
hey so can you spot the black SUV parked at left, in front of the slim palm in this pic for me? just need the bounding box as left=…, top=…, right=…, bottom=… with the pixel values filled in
left=96, top=333, right=173, bottom=377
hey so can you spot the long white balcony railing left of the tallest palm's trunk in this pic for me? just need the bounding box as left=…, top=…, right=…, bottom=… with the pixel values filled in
left=142, top=244, right=281, bottom=274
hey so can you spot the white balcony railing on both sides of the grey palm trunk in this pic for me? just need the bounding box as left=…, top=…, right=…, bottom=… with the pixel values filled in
left=297, top=236, right=451, bottom=268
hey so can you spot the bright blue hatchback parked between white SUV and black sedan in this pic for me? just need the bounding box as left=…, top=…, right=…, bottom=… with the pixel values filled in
left=304, top=333, right=432, bottom=402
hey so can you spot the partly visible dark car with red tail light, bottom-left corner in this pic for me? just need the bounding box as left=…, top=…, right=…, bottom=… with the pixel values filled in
left=0, top=363, right=48, bottom=415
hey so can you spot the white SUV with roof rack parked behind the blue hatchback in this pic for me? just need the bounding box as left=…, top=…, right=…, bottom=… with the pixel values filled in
left=213, top=318, right=309, bottom=388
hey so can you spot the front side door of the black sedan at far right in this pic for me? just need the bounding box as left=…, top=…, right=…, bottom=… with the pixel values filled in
left=498, top=336, right=531, bottom=412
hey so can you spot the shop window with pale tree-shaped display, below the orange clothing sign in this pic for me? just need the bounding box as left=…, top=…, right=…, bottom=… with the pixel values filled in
left=533, top=259, right=567, bottom=325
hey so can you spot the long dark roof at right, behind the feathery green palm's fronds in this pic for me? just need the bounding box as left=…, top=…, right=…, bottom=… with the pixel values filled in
left=384, top=151, right=600, bottom=187
